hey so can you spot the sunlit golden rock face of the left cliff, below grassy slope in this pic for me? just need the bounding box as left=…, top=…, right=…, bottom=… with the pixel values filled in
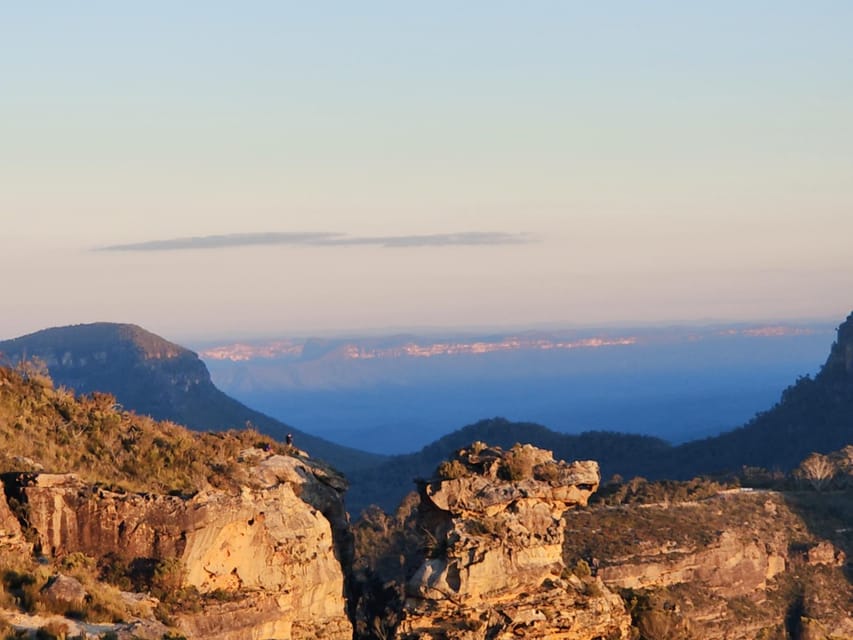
left=0, top=450, right=352, bottom=640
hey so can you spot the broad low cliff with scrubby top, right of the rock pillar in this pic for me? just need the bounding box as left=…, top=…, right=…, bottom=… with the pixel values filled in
left=564, top=491, right=853, bottom=640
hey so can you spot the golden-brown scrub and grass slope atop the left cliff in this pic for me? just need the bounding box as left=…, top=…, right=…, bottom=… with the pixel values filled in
left=0, top=363, right=285, bottom=494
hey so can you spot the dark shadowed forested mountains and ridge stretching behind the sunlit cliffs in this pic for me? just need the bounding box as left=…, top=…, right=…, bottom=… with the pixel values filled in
left=0, top=314, right=853, bottom=513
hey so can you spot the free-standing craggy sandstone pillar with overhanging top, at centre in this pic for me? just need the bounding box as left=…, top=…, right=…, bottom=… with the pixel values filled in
left=398, top=445, right=630, bottom=640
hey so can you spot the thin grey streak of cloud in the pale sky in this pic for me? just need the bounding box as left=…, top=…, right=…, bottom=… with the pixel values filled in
left=94, top=231, right=537, bottom=251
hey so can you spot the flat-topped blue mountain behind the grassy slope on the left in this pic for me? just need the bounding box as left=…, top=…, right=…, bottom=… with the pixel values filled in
left=0, top=322, right=382, bottom=471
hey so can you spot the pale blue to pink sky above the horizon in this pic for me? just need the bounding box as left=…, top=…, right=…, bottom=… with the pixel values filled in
left=0, top=0, right=853, bottom=340
